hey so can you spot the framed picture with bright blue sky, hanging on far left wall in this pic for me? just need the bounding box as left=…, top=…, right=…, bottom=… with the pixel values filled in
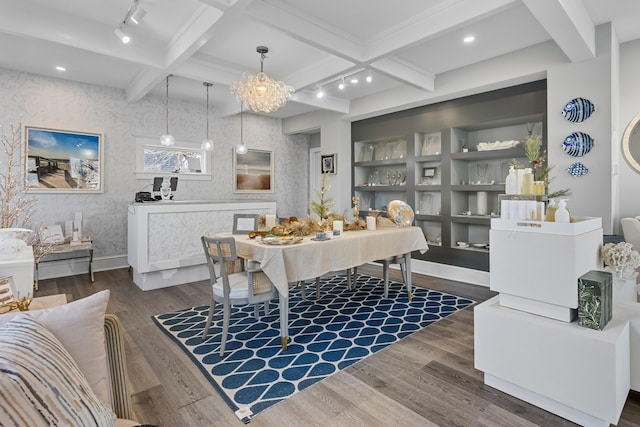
left=24, top=126, right=104, bottom=193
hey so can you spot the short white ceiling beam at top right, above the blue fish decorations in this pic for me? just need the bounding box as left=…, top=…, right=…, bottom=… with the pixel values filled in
left=522, top=0, right=596, bottom=62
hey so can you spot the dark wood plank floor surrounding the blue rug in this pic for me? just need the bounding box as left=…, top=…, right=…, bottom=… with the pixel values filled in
left=36, top=266, right=640, bottom=427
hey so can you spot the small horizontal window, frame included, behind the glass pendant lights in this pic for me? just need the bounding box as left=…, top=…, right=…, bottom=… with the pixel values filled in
left=136, top=137, right=211, bottom=180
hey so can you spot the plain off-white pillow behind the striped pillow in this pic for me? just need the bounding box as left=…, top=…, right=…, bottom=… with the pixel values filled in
left=0, top=290, right=112, bottom=406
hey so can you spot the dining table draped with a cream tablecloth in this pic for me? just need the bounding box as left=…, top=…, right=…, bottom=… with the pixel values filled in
left=224, top=225, right=429, bottom=350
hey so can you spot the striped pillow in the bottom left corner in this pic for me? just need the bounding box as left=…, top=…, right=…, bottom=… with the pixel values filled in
left=0, top=314, right=115, bottom=427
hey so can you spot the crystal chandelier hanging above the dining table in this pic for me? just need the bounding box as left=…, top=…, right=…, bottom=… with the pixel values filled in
left=231, top=46, right=294, bottom=113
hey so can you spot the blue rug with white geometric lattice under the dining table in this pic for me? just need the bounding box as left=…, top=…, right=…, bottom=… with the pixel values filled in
left=153, top=275, right=475, bottom=422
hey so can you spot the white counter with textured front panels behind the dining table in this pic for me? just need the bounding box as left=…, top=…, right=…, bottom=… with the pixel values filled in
left=127, top=201, right=276, bottom=291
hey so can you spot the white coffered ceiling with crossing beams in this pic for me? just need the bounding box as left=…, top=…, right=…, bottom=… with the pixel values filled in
left=0, top=0, right=640, bottom=118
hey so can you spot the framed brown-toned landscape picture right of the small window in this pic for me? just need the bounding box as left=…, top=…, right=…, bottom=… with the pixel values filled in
left=233, top=149, right=273, bottom=193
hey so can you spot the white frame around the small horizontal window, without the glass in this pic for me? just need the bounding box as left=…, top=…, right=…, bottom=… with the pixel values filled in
left=135, top=136, right=212, bottom=181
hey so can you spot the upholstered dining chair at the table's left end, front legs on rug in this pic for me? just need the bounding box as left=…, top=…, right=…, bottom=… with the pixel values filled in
left=201, top=236, right=278, bottom=356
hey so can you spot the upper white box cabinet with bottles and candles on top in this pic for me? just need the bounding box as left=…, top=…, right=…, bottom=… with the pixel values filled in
left=490, top=218, right=602, bottom=322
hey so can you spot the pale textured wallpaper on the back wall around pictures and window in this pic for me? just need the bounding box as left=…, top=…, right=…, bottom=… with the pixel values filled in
left=0, top=68, right=309, bottom=257
